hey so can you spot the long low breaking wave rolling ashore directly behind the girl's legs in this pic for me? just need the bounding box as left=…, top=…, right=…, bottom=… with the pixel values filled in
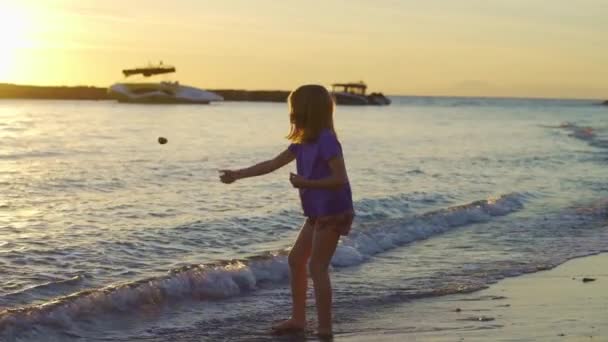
left=0, top=194, right=525, bottom=332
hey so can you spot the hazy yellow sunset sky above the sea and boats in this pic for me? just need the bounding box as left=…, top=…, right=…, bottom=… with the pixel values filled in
left=0, top=0, right=608, bottom=98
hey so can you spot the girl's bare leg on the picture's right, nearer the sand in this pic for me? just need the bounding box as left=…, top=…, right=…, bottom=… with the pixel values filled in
left=310, top=229, right=340, bottom=336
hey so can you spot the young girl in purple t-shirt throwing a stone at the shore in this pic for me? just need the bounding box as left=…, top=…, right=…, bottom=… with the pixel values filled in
left=220, top=85, right=354, bottom=337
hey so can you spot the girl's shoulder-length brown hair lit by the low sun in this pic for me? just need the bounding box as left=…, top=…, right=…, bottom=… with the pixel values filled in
left=287, top=84, right=336, bottom=143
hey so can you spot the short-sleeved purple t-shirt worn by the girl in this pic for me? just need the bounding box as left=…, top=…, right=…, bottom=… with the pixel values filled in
left=289, top=129, right=353, bottom=217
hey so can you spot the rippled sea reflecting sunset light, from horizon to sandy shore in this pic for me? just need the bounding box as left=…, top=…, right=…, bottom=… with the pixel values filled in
left=0, top=97, right=608, bottom=341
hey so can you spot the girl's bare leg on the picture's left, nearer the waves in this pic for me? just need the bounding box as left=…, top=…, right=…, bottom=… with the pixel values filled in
left=272, top=220, right=313, bottom=332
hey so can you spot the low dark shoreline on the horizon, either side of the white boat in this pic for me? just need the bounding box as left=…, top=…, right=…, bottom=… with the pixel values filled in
left=0, top=83, right=289, bottom=102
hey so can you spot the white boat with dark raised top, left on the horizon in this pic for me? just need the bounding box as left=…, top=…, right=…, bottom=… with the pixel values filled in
left=108, top=62, right=224, bottom=104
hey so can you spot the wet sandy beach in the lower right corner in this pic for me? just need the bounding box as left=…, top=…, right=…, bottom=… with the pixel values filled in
left=339, top=254, right=608, bottom=341
